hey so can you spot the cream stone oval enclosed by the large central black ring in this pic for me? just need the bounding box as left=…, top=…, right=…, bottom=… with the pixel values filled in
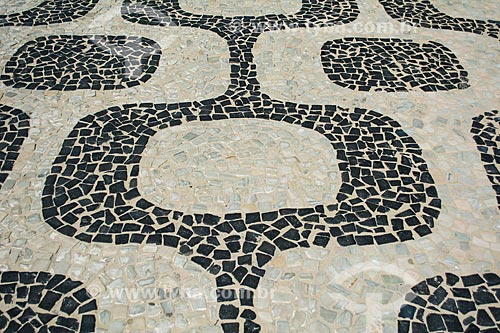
left=138, top=119, right=340, bottom=215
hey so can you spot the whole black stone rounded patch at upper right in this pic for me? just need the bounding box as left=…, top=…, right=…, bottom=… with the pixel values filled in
left=321, top=38, right=469, bottom=92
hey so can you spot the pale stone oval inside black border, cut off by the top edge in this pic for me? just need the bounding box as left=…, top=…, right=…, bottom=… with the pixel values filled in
left=179, top=0, right=302, bottom=16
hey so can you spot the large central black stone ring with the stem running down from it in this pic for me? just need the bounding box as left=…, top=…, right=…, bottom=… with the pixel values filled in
left=42, top=96, right=440, bottom=332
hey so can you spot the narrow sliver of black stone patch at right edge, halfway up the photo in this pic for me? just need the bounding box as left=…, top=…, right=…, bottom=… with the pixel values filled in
left=471, top=110, right=500, bottom=209
